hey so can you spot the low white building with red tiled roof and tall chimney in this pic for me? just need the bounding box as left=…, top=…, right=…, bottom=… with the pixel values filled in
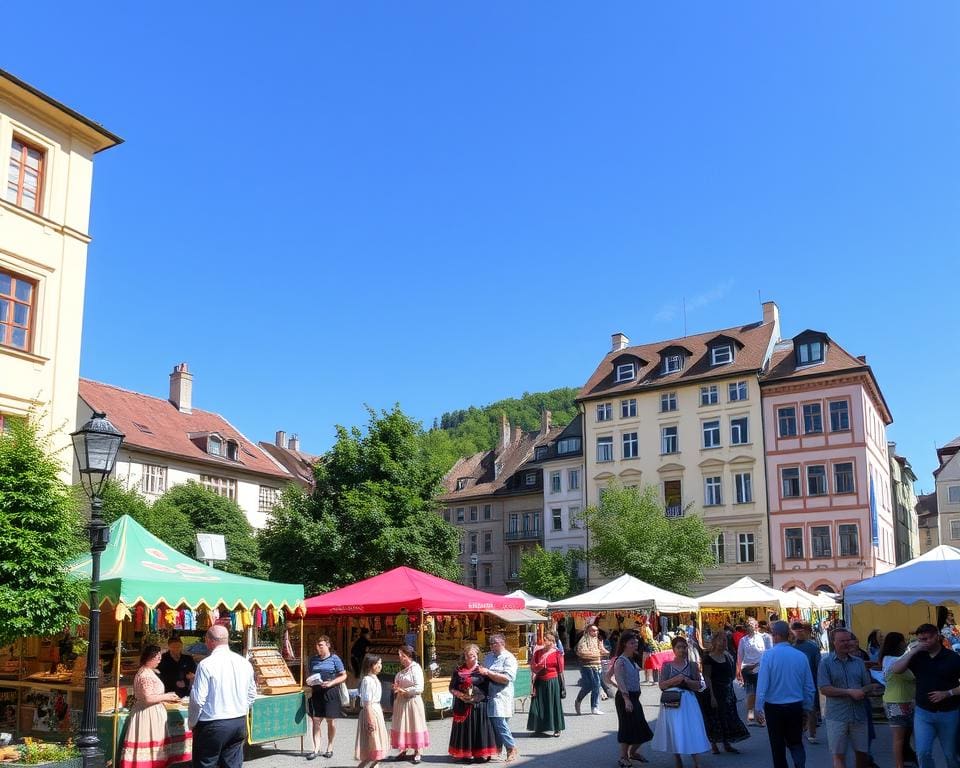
left=75, top=363, right=294, bottom=528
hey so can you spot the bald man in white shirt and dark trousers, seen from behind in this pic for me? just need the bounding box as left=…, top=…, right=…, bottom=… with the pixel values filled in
left=187, top=624, right=257, bottom=768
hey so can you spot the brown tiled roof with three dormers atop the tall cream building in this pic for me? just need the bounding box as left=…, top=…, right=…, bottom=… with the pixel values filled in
left=577, top=323, right=774, bottom=400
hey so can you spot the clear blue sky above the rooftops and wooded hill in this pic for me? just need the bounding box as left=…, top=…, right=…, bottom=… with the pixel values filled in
left=0, top=1, right=960, bottom=489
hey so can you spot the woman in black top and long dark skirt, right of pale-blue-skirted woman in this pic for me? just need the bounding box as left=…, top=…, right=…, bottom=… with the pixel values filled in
left=698, top=632, right=750, bottom=755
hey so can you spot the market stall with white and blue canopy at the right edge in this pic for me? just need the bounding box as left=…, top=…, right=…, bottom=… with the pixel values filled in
left=843, top=544, right=960, bottom=641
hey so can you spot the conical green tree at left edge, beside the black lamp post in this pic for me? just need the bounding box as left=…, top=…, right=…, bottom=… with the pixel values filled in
left=0, top=419, right=87, bottom=645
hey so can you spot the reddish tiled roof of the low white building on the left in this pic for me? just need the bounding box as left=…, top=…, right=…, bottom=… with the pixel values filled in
left=79, top=379, right=292, bottom=480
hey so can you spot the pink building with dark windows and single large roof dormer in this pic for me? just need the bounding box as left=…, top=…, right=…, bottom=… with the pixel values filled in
left=760, top=330, right=896, bottom=592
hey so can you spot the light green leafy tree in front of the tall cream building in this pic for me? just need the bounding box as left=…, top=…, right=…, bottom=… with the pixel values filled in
left=584, top=485, right=713, bottom=594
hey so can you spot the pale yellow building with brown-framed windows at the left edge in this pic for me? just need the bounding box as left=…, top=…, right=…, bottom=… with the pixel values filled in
left=0, top=70, right=122, bottom=468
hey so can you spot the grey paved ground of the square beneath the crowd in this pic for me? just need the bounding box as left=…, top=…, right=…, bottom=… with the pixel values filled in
left=245, top=670, right=945, bottom=768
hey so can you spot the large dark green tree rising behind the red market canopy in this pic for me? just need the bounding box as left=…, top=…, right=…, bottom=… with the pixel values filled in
left=259, top=405, right=460, bottom=594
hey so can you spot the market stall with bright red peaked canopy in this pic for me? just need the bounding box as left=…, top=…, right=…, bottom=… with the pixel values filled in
left=304, top=566, right=546, bottom=712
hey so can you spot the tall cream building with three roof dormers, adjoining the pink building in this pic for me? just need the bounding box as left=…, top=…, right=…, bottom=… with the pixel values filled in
left=577, top=302, right=780, bottom=593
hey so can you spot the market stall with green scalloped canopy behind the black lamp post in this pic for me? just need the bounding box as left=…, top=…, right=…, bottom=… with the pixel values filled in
left=0, top=516, right=305, bottom=759
